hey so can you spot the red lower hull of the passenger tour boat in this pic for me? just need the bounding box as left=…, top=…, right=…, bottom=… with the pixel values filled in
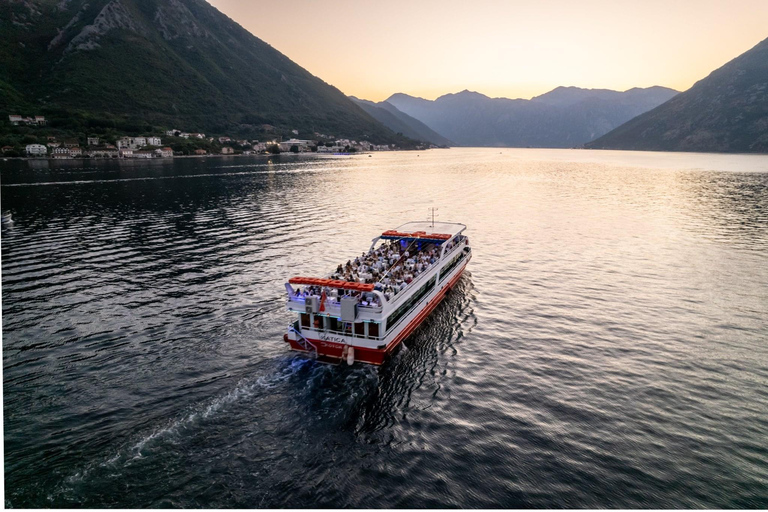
left=283, top=261, right=469, bottom=365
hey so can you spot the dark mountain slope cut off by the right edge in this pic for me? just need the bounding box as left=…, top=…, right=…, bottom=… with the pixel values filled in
left=587, top=39, right=768, bottom=153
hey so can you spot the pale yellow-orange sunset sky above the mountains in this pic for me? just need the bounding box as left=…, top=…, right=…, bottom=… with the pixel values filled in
left=209, top=0, right=768, bottom=101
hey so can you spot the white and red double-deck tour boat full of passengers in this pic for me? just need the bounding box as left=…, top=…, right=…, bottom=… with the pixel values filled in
left=283, top=221, right=472, bottom=365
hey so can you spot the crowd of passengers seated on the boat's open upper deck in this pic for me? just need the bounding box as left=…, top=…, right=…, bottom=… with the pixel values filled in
left=296, top=237, right=464, bottom=307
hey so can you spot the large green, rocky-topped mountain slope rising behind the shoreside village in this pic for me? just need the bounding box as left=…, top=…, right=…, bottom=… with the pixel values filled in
left=0, top=0, right=405, bottom=143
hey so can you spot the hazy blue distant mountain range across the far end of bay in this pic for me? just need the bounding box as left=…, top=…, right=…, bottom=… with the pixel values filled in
left=386, top=87, right=677, bottom=148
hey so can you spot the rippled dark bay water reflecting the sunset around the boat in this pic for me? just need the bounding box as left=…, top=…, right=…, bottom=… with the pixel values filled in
left=0, top=149, right=768, bottom=508
